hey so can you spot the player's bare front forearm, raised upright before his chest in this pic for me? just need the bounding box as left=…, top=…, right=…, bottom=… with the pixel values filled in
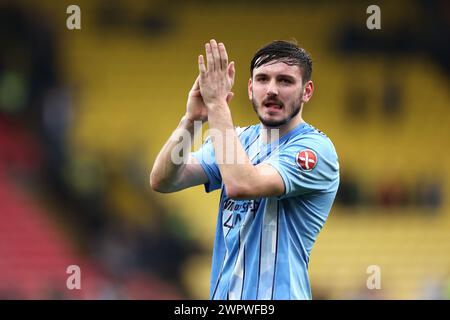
left=208, top=102, right=258, bottom=198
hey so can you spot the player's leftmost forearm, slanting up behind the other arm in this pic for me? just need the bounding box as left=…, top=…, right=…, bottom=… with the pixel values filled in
left=150, top=116, right=195, bottom=192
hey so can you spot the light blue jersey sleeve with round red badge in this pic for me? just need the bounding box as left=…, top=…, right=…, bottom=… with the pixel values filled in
left=264, top=134, right=339, bottom=198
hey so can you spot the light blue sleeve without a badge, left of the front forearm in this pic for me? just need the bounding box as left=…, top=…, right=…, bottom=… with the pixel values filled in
left=192, top=137, right=222, bottom=192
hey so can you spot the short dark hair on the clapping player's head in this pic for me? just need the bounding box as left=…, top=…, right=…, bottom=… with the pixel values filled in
left=250, top=40, right=312, bottom=84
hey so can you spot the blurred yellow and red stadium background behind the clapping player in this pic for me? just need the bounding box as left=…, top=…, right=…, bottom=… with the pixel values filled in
left=0, top=0, right=450, bottom=299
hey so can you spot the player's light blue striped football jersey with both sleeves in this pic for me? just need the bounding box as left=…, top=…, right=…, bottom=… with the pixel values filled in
left=193, top=123, right=339, bottom=300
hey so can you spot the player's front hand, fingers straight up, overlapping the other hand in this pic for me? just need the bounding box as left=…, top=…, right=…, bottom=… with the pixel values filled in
left=198, top=39, right=235, bottom=108
